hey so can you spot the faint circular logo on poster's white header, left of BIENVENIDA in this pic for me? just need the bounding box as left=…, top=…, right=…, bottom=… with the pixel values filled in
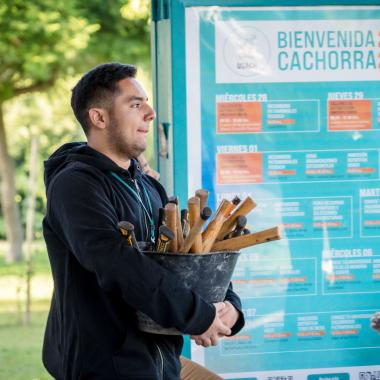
left=223, top=26, right=270, bottom=77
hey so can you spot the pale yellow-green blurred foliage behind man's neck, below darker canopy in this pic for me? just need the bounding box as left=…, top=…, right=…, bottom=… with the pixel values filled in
left=5, top=78, right=84, bottom=239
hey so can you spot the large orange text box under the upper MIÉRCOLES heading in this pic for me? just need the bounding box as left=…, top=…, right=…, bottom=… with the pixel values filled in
left=216, top=102, right=263, bottom=133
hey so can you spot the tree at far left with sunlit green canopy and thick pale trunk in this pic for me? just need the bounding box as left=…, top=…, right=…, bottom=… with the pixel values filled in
left=0, top=0, right=98, bottom=262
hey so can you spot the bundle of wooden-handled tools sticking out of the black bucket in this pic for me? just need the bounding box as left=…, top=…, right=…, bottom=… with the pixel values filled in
left=119, top=189, right=280, bottom=254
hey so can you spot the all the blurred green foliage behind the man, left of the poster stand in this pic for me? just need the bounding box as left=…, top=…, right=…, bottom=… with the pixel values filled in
left=0, top=0, right=152, bottom=245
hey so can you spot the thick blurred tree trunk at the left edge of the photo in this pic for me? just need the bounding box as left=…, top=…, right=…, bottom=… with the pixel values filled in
left=0, top=103, right=23, bottom=263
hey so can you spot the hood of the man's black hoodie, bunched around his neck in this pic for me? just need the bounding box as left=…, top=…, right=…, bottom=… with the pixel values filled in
left=44, top=142, right=141, bottom=188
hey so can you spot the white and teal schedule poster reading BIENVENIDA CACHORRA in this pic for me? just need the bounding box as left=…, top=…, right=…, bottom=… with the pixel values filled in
left=186, top=7, right=380, bottom=380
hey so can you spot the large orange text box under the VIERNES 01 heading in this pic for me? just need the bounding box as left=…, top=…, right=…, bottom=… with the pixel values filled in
left=216, top=153, right=263, bottom=185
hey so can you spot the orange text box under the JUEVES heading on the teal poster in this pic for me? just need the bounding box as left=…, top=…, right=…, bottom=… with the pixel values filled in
left=329, top=99, right=372, bottom=131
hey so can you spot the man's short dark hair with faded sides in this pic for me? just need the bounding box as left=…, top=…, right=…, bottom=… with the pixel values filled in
left=71, top=63, right=137, bottom=135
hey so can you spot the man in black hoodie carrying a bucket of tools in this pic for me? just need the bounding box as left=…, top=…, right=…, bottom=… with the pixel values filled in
left=43, top=63, right=244, bottom=380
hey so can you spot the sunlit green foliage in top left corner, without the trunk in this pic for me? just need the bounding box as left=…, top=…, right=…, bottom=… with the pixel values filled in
left=0, top=0, right=99, bottom=102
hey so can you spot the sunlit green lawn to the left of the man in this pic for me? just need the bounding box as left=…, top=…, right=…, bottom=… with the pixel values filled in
left=0, top=244, right=52, bottom=380
